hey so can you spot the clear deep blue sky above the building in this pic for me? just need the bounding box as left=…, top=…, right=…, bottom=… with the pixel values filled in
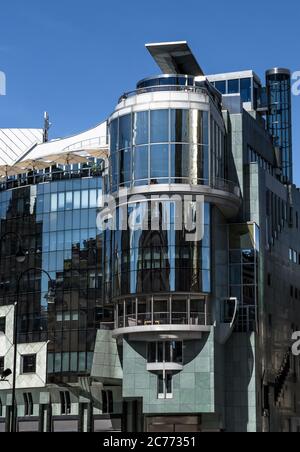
left=0, top=0, right=300, bottom=185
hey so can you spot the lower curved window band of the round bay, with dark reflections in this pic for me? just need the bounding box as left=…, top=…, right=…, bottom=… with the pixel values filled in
left=103, top=201, right=211, bottom=301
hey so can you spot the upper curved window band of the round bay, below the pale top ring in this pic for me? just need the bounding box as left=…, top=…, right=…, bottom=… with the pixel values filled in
left=110, top=109, right=212, bottom=191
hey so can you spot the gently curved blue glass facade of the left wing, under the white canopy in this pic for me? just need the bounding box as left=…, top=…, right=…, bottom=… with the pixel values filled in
left=0, top=177, right=111, bottom=381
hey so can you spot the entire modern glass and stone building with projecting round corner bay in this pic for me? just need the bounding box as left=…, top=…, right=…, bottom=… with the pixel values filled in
left=0, top=42, right=300, bottom=432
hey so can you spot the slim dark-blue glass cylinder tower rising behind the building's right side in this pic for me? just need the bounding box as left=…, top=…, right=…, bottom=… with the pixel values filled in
left=266, top=68, right=293, bottom=183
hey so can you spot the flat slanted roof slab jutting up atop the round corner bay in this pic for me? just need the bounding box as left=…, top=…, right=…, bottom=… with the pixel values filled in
left=146, top=41, right=204, bottom=76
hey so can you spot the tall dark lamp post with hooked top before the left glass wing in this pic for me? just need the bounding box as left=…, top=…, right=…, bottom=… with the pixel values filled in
left=10, top=267, right=55, bottom=433
